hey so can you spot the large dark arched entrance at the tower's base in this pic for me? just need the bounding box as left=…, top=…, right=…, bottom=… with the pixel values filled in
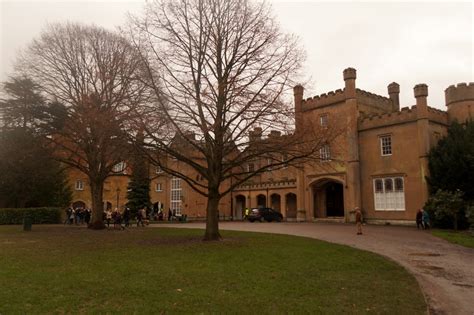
left=312, top=179, right=344, bottom=218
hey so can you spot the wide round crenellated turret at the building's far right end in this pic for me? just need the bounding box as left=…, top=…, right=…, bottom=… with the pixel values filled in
left=444, top=82, right=474, bottom=122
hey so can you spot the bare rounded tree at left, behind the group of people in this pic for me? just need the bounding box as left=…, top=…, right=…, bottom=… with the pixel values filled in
left=18, top=23, right=145, bottom=228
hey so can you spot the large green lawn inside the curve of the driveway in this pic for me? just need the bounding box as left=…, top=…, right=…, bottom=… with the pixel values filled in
left=0, top=225, right=426, bottom=314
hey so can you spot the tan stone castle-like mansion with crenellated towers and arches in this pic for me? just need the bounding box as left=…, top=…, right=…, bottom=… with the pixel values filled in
left=69, top=68, right=474, bottom=223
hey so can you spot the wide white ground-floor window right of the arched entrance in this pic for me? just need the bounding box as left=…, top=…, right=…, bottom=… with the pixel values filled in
left=374, top=177, right=405, bottom=211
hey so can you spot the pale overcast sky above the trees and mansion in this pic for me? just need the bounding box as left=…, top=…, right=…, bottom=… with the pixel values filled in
left=0, top=0, right=474, bottom=109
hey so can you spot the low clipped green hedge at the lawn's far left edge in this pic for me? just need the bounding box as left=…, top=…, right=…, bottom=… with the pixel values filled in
left=0, top=208, right=62, bottom=224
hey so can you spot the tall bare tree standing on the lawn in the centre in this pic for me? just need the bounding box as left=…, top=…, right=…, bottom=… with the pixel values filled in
left=130, top=0, right=336, bottom=240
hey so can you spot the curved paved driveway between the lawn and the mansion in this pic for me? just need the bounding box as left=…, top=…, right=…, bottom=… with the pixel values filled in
left=155, top=222, right=474, bottom=315
